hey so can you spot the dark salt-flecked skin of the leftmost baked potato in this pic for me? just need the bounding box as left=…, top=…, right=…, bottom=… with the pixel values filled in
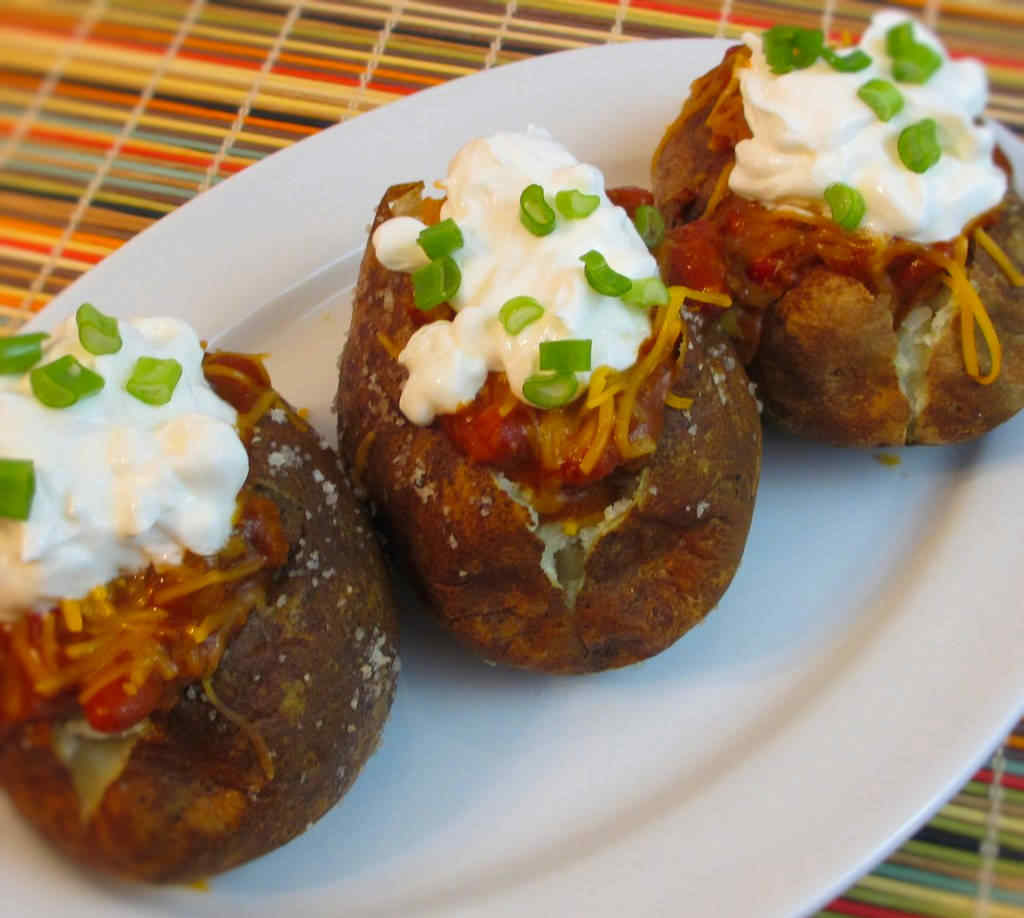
left=0, top=399, right=397, bottom=882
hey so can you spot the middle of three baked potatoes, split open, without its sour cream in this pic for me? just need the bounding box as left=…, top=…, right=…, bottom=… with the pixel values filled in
left=337, top=177, right=761, bottom=673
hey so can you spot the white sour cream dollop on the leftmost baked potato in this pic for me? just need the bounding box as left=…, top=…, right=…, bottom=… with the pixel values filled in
left=0, top=317, right=249, bottom=621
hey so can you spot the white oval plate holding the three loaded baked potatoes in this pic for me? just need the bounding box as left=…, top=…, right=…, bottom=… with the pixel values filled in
left=8, top=40, right=1024, bottom=918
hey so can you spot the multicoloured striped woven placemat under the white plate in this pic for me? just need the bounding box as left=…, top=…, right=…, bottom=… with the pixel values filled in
left=0, top=0, right=1024, bottom=918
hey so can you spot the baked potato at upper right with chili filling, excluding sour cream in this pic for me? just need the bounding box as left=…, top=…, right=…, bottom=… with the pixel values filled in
left=652, top=37, right=1024, bottom=447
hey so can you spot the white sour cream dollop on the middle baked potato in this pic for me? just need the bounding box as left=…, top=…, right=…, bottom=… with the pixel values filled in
left=373, top=127, right=657, bottom=424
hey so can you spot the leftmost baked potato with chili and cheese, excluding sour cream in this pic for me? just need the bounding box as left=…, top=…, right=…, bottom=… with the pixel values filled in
left=0, top=346, right=398, bottom=882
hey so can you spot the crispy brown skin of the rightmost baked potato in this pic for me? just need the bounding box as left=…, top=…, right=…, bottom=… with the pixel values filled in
left=651, top=51, right=1024, bottom=447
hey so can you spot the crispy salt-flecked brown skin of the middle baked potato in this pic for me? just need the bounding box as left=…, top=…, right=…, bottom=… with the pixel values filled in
left=337, top=185, right=761, bottom=673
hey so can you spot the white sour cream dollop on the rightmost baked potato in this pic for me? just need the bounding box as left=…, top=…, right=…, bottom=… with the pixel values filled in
left=729, top=10, right=1007, bottom=244
